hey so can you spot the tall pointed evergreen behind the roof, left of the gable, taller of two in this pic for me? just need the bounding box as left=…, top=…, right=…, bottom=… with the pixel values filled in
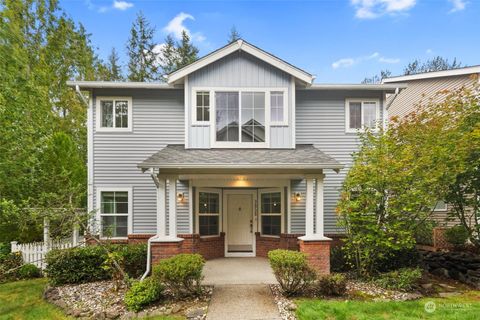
left=127, top=12, right=159, bottom=81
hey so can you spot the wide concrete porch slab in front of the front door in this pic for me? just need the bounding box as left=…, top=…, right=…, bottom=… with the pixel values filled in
left=203, top=257, right=277, bottom=286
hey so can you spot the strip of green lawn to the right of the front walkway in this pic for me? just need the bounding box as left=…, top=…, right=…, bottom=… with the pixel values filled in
left=297, top=291, right=480, bottom=320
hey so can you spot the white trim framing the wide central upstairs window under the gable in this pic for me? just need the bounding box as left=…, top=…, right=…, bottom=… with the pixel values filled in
left=190, top=87, right=290, bottom=148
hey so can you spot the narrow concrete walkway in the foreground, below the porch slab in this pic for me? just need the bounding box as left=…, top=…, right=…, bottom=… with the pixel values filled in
left=207, top=284, right=281, bottom=320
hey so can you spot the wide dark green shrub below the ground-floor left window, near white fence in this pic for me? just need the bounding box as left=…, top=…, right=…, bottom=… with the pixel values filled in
left=45, top=246, right=110, bottom=286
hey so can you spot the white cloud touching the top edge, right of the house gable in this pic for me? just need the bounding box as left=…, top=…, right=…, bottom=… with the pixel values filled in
left=350, top=0, right=416, bottom=19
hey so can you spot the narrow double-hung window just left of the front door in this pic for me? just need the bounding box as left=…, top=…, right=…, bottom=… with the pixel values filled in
left=197, top=189, right=221, bottom=236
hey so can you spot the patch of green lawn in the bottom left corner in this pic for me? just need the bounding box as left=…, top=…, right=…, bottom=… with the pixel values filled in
left=0, top=279, right=184, bottom=320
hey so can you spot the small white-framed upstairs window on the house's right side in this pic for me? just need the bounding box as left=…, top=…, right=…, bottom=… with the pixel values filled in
left=345, top=99, right=380, bottom=132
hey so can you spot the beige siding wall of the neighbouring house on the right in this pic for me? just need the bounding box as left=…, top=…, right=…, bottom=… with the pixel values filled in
left=389, top=75, right=478, bottom=118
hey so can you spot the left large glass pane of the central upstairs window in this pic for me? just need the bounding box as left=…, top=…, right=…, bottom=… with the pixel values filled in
left=215, top=92, right=240, bottom=141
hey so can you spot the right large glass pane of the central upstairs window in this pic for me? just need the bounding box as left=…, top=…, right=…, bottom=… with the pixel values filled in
left=242, top=92, right=265, bottom=142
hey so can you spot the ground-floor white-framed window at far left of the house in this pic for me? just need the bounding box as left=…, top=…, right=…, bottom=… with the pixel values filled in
left=98, top=188, right=132, bottom=238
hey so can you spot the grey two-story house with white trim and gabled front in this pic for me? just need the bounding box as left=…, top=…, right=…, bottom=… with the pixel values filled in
left=69, top=40, right=405, bottom=272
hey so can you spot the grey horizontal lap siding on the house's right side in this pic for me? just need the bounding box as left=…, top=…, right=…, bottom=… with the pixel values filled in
left=291, top=89, right=383, bottom=234
